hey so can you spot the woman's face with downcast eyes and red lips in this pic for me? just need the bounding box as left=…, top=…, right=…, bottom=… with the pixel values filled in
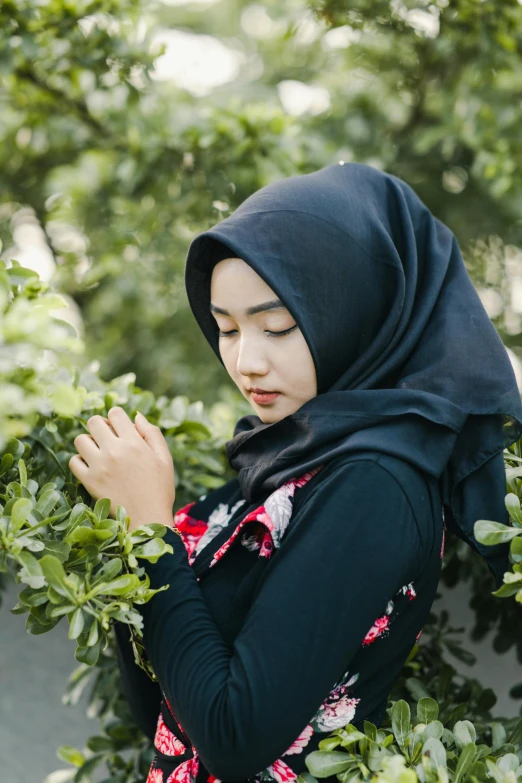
left=210, top=258, right=317, bottom=424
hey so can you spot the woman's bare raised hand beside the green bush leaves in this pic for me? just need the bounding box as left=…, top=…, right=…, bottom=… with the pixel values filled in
left=69, top=406, right=176, bottom=530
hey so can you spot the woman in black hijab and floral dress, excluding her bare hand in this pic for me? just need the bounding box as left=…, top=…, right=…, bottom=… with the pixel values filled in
left=110, top=163, right=522, bottom=783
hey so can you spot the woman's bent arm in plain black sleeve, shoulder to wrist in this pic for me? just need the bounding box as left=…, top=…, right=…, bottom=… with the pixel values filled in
left=140, top=460, right=432, bottom=781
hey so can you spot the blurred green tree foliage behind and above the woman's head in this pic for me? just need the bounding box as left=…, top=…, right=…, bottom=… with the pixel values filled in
left=0, top=0, right=522, bottom=404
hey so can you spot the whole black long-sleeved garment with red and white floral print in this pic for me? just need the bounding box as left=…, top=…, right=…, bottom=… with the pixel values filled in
left=112, top=452, right=444, bottom=783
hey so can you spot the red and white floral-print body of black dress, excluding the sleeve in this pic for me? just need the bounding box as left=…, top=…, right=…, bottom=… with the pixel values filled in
left=115, top=458, right=444, bottom=783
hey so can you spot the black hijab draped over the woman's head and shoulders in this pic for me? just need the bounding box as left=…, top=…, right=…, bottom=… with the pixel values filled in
left=185, top=163, right=522, bottom=585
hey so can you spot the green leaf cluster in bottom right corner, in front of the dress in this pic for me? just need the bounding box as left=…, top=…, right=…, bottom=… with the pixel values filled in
left=300, top=698, right=522, bottom=783
